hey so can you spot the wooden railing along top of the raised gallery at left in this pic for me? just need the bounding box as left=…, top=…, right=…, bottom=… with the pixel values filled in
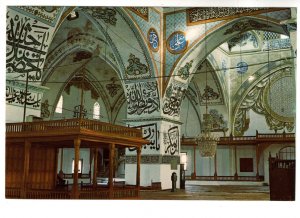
left=6, top=119, right=142, bottom=137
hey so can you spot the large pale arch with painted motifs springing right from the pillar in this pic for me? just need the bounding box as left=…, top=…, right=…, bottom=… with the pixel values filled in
left=163, top=16, right=286, bottom=121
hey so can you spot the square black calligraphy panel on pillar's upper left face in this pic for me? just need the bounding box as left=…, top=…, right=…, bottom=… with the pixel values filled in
left=125, top=82, right=160, bottom=115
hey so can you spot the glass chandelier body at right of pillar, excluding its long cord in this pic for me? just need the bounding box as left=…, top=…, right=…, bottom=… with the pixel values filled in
left=196, top=113, right=218, bottom=157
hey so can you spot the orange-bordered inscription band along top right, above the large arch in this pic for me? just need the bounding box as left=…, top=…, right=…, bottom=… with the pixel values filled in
left=187, top=7, right=286, bottom=26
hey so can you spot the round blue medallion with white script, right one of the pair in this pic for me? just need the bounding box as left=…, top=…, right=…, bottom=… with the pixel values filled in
left=167, top=31, right=188, bottom=54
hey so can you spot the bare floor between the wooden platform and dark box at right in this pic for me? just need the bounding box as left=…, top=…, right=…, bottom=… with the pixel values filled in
left=140, top=185, right=270, bottom=201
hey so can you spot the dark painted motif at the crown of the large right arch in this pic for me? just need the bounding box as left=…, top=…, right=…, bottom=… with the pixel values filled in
left=224, top=20, right=271, bottom=35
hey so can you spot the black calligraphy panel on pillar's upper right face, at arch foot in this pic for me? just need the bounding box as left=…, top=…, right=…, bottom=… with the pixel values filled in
left=163, top=84, right=185, bottom=116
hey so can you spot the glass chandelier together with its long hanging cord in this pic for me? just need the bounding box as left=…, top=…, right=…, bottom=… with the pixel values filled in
left=196, top=17, right=218, bottom=157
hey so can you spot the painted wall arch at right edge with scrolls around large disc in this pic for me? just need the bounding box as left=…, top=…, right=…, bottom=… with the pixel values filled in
left=234, top=67, right=295, bottom=135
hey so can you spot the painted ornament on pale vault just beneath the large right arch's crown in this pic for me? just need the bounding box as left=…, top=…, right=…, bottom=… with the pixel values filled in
left=227, top=32, right=258, bottom=51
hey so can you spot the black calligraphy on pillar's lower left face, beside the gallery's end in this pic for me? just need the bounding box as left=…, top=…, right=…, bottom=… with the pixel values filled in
left=129, top=123, right=160, bottom=151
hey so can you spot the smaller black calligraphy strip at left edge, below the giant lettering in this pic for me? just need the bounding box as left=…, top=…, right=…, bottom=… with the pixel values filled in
left=6, top=86, right=42, bottom=108
